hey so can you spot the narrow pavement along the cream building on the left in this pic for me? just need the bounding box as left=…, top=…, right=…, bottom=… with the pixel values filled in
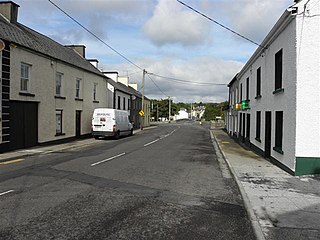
left=0, top=126, right=145, bottom=165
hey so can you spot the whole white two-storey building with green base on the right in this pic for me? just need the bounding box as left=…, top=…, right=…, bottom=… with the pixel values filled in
left=226, top=0, right=320, bottom=175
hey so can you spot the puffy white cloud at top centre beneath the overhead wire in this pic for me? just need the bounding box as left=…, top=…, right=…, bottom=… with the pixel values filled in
left=143, top=0, right=210, bottom=46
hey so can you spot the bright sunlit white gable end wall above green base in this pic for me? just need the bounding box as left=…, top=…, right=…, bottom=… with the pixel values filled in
left=295, top=0, right=320, bottom=157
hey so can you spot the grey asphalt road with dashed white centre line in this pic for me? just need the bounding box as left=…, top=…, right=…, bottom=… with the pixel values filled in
left=0, top=122, right=254, bottom=240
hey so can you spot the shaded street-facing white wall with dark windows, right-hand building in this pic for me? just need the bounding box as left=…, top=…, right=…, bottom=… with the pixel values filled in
left=239, top=18, right=296, bottom=169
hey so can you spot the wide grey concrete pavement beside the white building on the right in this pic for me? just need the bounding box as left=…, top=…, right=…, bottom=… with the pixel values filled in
left=212, top=129, right=320, bottom=240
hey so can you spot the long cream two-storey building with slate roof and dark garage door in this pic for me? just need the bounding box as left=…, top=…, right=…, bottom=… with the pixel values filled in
left=0, top=1, right=108, bottom=152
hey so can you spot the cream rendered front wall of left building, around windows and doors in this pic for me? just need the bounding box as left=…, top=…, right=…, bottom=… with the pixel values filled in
left=10, top=47, right=107, bottom=143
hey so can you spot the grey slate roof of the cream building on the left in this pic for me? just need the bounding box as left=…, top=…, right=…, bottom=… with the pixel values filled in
left=0, top=15, right=105, bottom=77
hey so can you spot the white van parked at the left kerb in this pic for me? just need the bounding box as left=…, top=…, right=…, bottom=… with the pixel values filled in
left=92, top=108, right=133, bottom=139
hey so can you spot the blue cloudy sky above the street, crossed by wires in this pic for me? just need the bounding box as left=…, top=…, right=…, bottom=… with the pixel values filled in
left=14, top=0, right=293, bottom=103
